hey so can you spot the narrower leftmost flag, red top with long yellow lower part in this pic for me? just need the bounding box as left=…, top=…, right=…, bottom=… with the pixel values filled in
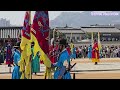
left=19, top=11, right=31, bottom=79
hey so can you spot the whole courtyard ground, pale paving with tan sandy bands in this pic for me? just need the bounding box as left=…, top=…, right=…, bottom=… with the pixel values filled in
left=0, top=58, right=120, bottom=79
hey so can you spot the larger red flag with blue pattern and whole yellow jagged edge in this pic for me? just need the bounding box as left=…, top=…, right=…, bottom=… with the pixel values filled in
left=31, top=11, right=50, bottom=66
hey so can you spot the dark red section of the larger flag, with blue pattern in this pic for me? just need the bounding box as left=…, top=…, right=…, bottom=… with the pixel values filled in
left=32, top=11, right=49, bottom=54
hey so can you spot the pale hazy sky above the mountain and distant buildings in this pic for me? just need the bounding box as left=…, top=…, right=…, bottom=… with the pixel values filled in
left=0, top=11, right=83, bottom=26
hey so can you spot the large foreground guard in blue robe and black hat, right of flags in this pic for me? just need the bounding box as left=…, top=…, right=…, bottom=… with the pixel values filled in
left=54, top=39, right=71, bottom=79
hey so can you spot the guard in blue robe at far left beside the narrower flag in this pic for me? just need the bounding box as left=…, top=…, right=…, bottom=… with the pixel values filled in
left=12, top=43, right=21, bottom=79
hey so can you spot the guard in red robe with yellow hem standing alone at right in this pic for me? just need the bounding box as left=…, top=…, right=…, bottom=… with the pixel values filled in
left=92, top=40, right=100, bottom=65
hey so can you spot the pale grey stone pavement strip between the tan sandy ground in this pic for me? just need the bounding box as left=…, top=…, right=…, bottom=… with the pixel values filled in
left=0, top=58, right=120, bottom=73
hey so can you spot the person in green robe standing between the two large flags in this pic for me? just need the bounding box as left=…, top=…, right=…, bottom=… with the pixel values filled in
left=31, top=42, right=40, bottom=75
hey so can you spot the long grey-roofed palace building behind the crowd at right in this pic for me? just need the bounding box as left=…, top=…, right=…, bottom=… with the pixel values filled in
left=56, top=25, right=120, bottom=45
